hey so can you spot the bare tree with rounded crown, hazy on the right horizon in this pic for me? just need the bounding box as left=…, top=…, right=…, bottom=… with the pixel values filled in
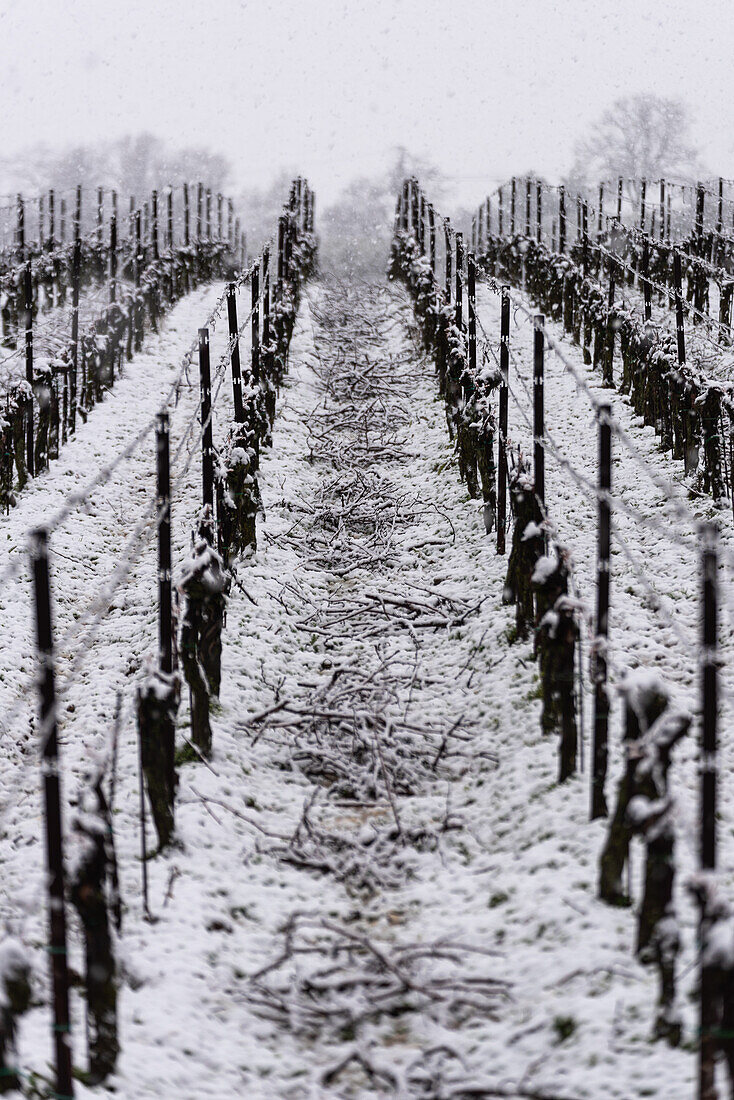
left=569, top=95, right=698, bottom=201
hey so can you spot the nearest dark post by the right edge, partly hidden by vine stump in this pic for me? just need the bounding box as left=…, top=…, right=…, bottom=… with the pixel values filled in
left=699, top=523, right=719, bottom=1100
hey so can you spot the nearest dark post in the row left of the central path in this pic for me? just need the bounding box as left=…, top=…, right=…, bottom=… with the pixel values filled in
left=31, top=527, right=74, bottom=1098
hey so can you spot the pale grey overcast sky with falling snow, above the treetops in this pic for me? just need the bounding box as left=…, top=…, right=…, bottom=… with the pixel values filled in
left=0, top=0, right=734, bottom=202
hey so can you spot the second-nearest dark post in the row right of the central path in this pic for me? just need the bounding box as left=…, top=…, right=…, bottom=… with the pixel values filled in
left=591, top=405, right=612, bottom=821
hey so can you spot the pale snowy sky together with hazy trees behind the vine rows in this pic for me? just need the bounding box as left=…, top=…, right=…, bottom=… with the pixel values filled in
left=0, top=0, right=734, bottom=275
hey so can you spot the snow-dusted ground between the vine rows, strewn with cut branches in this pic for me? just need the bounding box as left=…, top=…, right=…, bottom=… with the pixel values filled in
left=0, top=270, right=734, bottom=1100
